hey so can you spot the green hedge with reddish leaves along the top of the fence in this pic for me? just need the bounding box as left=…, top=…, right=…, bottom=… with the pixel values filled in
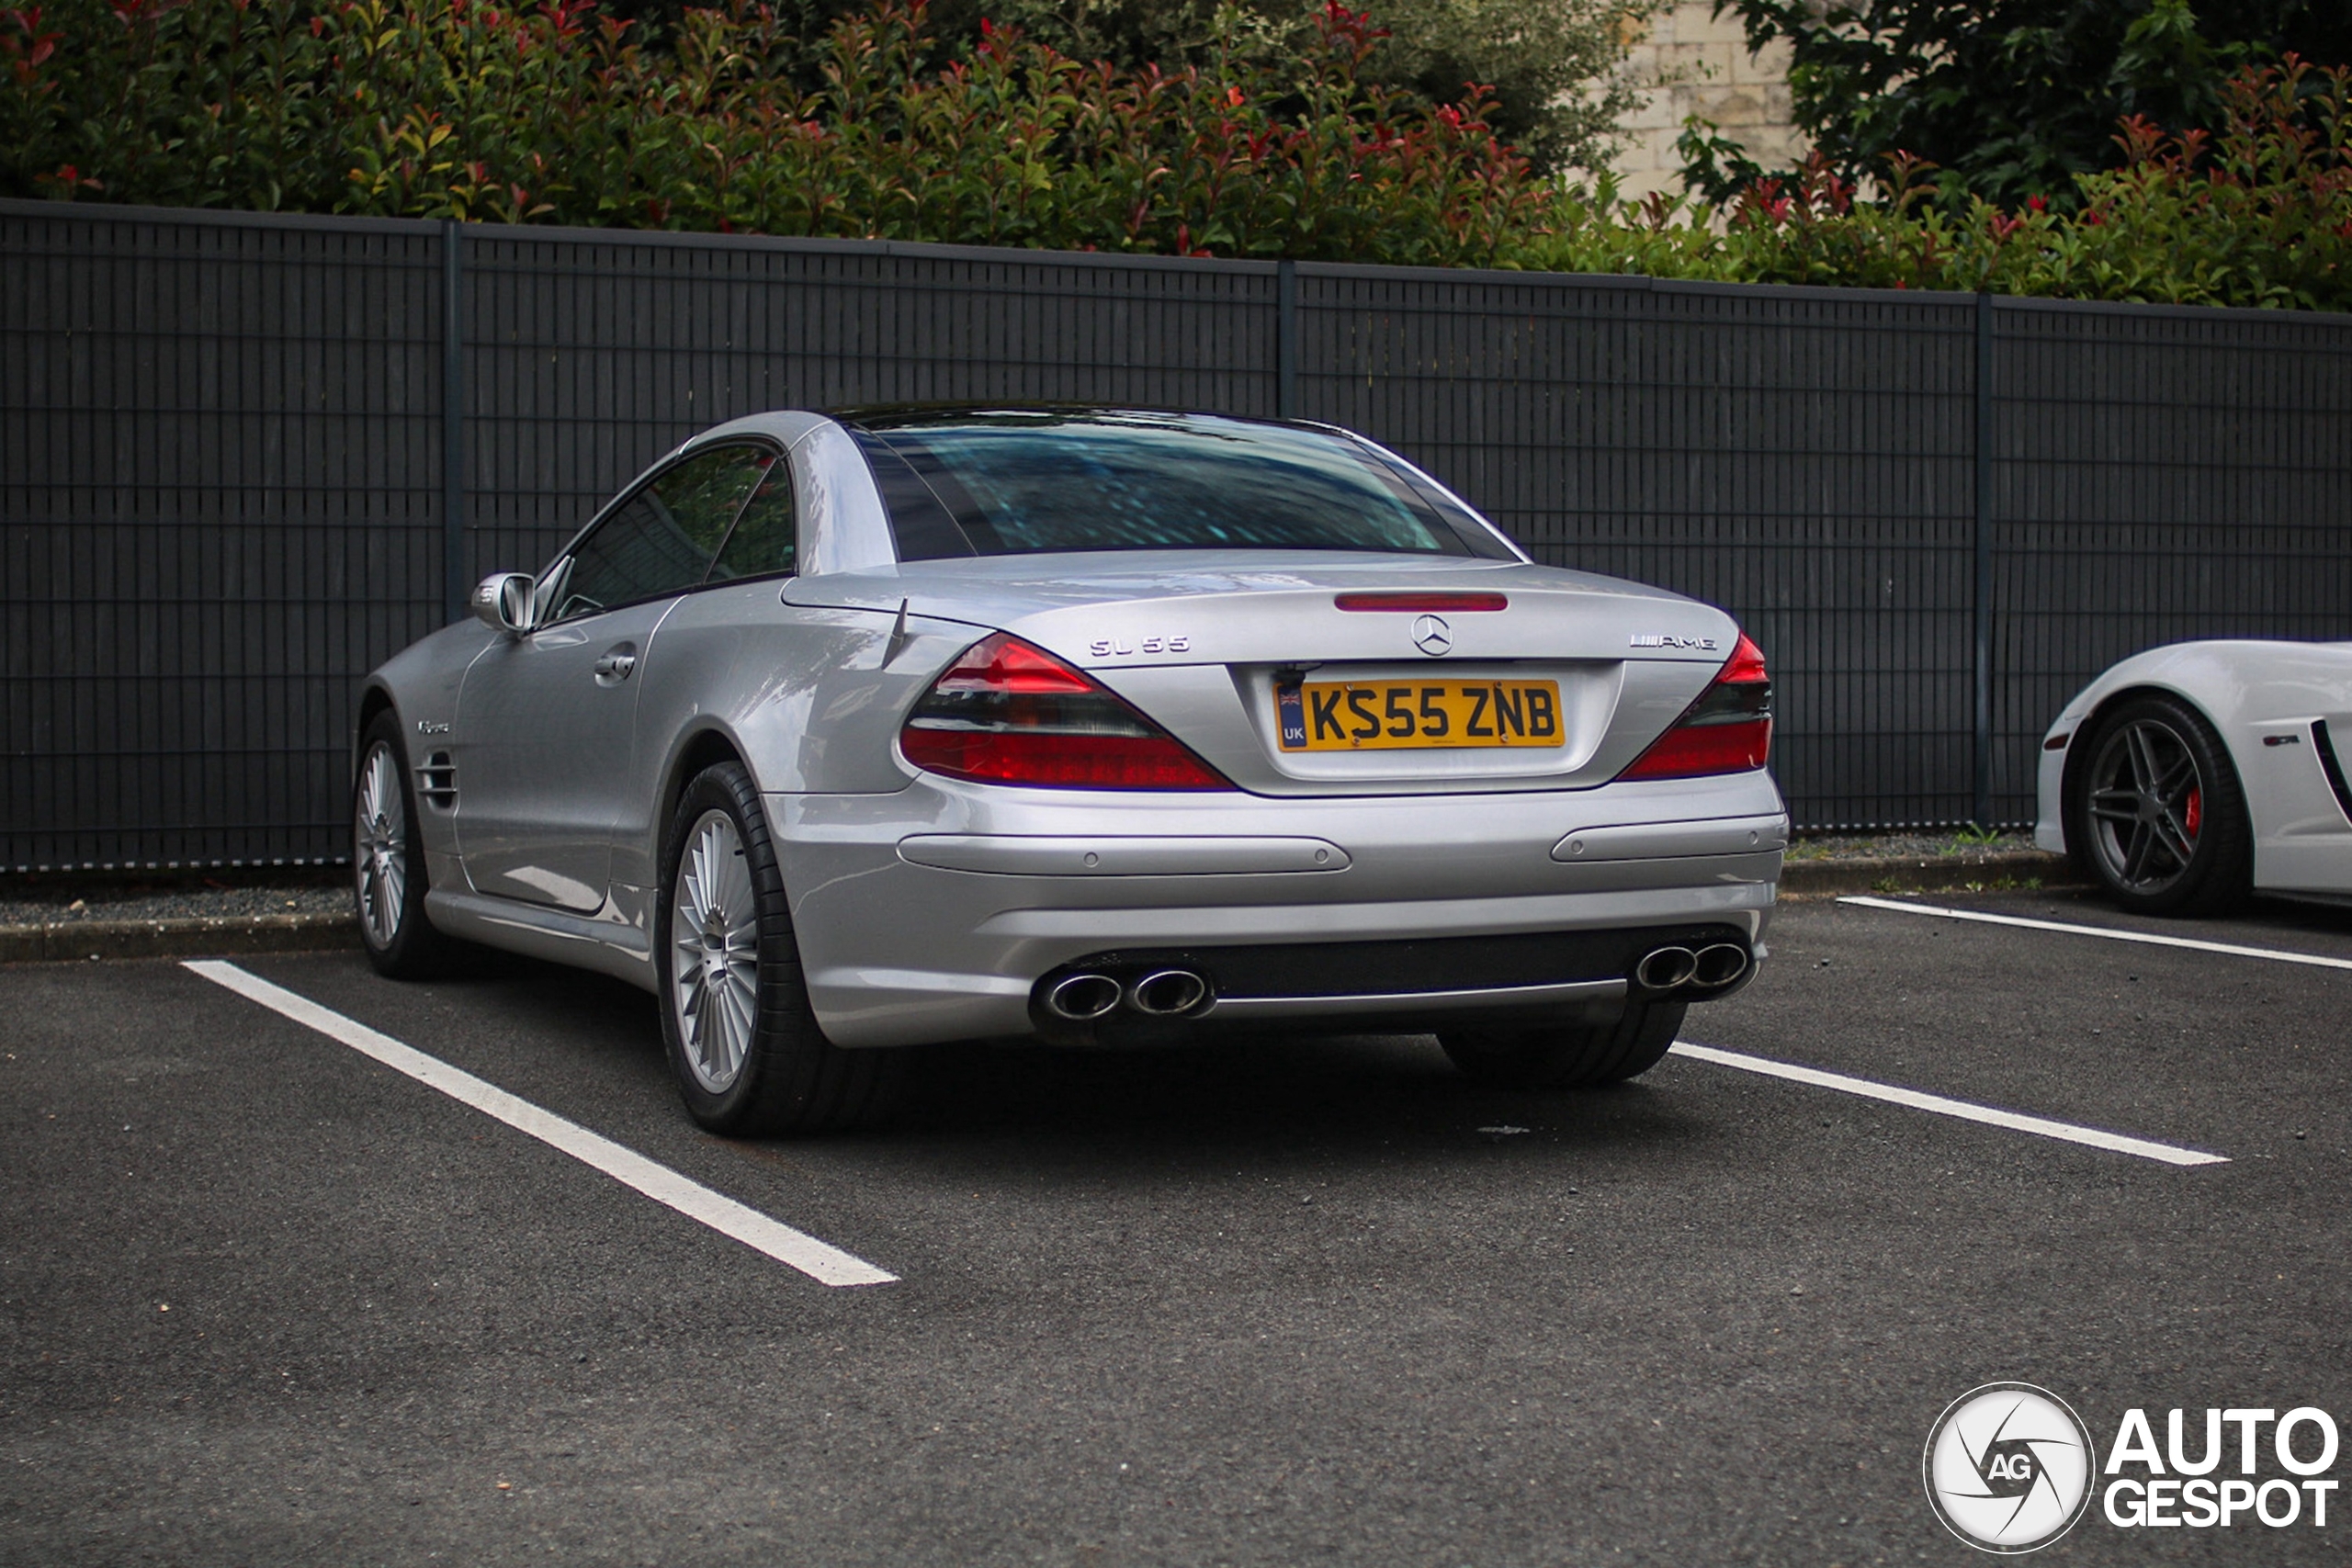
left=0, top=0, right=2352, bottom=310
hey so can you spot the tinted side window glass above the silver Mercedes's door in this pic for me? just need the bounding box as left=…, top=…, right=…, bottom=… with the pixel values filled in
left=555, top=446, right=776, bottom=621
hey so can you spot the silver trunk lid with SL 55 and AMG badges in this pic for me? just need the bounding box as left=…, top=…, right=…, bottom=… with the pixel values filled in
left=783, top=552, right=1738, bottom=795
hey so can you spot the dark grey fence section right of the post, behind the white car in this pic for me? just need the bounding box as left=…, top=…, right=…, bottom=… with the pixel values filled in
left=1990, top=301, right=2352, bottom=822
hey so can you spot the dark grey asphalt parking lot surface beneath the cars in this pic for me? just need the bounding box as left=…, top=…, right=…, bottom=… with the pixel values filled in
left=0, top=894, right=2352, bottom=1568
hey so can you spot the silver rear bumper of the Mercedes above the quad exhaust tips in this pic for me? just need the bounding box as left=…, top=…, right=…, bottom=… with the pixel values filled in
left=767, top=773, right=1788, bottom=1046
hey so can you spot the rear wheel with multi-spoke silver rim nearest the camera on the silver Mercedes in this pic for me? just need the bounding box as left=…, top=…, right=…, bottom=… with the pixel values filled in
left=654, top=761, right=906, bottom=1138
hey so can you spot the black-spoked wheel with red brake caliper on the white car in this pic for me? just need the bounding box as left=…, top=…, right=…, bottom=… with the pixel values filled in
left=2065, top=694, right=2253, bottom=915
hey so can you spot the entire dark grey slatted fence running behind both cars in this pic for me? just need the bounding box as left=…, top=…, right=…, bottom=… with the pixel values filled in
left=0, top=202, right=2352, bottom=870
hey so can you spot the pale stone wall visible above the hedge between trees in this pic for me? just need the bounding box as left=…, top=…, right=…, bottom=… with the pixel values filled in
left=1616, top=0, right=1804, bottom=200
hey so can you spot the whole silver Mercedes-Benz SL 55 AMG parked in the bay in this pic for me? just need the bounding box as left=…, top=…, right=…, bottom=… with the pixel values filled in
left=353, top=407, right=1788, bottom=1135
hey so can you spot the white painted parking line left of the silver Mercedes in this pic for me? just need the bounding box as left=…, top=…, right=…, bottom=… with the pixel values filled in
left=184, top=959, right=899, bottom=1286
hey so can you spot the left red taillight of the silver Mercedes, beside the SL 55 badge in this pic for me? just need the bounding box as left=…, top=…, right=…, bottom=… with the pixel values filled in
left=899, top=632, right=1232, bottom=790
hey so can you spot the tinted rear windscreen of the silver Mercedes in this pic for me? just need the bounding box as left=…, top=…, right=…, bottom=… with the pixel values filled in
left=849, top=409, right=1503, bottom=562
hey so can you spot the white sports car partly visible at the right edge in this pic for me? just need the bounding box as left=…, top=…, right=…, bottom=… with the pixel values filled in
left=2034, top=642, right=2352, bottom=915
